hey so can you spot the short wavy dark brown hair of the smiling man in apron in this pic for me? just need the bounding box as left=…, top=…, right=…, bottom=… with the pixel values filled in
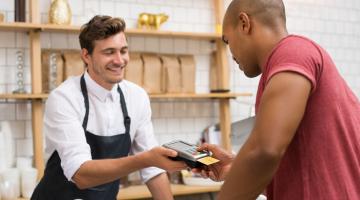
left=79, top=15, right=126, bottom=54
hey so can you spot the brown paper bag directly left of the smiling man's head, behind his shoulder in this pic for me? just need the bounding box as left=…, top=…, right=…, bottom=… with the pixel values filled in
left=63, top=50, right=85, bottom=80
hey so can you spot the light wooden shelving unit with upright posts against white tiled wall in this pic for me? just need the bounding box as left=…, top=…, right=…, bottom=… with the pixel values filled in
left=0, top=0, right=245, bottom=199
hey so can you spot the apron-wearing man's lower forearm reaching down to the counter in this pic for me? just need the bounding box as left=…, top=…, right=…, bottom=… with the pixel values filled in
left=146, top=173, right=174, bottom=200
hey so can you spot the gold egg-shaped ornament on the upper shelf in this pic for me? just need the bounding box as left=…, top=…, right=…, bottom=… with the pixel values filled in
left=49, top=0, right=71, bottom=25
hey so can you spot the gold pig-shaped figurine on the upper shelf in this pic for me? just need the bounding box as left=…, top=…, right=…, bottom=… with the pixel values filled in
left=137, top=13, right=169, bottom=30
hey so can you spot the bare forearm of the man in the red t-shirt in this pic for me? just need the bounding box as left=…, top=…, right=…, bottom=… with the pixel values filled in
left=218, top=141, right=281, bottom=200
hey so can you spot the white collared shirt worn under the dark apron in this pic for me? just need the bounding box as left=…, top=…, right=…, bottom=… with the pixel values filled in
left=44, top=72, right=164, bottom=182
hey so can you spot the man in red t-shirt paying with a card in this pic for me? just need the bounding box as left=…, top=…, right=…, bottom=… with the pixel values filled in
left=194, top=0, right=360, bottom=200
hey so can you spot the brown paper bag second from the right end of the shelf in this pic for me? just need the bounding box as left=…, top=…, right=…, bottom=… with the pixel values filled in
left=161, top=55, right=182, bottom=93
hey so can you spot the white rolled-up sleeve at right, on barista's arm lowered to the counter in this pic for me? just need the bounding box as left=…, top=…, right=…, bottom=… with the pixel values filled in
left=131, top=93, right=165, bottom=182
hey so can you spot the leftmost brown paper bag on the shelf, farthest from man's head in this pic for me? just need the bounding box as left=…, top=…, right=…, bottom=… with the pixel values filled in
left=41, top=50, right=64, bottom=93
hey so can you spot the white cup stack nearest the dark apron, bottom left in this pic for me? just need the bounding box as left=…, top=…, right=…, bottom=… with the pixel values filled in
left=21, top=168, right=38, bottom=198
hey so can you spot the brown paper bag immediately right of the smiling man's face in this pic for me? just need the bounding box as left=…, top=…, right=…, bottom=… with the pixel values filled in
left=125, top=53, right=144, bottom=87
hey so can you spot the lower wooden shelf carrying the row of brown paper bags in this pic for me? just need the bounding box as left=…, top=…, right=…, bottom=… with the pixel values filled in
left=0, top=93, right=252, bottom=100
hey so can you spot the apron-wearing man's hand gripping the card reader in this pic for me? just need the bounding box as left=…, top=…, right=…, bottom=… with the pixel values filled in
left=148, top=147, right=187, bottom=172
